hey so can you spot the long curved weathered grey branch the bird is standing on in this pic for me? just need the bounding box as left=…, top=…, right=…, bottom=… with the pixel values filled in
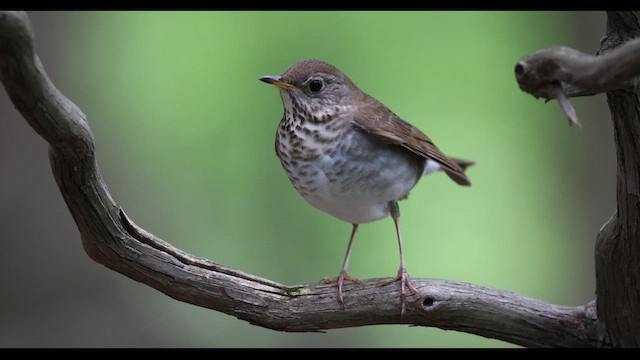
left=0, top=12, right=605, bottom=347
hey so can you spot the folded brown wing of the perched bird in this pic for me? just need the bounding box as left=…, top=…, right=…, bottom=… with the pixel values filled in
left=353, top=97, right=471, bottom=186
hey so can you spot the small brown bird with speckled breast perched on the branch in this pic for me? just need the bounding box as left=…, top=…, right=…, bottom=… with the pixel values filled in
left=259, top=59, right=474, bottom=316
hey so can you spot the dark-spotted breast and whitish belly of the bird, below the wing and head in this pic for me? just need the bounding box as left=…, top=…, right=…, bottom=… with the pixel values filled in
left=276, top=114, right=424, bottom=224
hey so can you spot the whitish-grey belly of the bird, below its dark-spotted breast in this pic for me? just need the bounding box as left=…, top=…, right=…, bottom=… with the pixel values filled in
left=285, top=132, right=423, bottom=224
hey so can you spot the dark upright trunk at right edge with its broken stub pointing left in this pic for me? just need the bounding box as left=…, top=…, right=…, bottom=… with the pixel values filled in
left=515, top=11, right=640, bottom=347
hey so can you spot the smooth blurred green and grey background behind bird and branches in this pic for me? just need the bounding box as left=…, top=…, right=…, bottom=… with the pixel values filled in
left=0, top=11, right=615, bottom=347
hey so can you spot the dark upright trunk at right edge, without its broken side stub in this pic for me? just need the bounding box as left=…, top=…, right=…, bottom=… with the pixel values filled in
left=595, top=11, right=640, bottom=347
